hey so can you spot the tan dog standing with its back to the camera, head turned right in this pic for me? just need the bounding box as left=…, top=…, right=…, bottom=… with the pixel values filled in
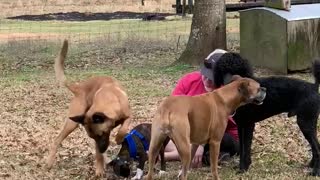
left=146, top=75, right=266, bottom=180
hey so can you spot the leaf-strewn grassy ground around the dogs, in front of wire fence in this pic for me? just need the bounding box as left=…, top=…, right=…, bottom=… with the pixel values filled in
left=0, top=40, right=320, bottom=179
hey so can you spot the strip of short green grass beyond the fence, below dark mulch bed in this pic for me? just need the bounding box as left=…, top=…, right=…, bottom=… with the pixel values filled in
left=0, top=20, right=191, bottom=38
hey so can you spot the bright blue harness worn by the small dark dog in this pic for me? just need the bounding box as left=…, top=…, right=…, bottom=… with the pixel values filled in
left=124, top=129, right=149, bottom=159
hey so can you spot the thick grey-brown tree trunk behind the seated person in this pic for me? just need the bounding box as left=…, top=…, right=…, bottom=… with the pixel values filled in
left=177, top=0, right=226, bottom=65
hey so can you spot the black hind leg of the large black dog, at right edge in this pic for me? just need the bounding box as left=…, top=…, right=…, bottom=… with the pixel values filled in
left=297, top=113, right=320, bottom=176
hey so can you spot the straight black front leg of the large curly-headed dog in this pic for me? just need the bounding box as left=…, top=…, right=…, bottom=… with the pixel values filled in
left=238, top=123, right=255, bottom=173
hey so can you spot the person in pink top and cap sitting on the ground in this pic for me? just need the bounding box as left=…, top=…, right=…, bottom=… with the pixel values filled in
left=165, top=49, right=239, bottom=167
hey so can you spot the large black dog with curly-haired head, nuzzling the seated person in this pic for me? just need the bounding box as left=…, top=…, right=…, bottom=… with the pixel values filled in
left=205, top=52, right=320, bottom=176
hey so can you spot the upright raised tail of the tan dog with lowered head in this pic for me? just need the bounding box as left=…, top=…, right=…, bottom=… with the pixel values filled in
left=54, top=39, right=79, bottom=94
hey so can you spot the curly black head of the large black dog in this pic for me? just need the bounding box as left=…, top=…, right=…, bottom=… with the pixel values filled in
left=212, top=52, right=253, bottom=87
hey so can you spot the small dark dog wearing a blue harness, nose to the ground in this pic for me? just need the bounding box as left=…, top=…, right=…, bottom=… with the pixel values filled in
left=109, top=123, right=170, bottom=180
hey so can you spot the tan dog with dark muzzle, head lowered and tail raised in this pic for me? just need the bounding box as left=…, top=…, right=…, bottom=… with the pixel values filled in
left=47, top=40, right=131, bottom=176
